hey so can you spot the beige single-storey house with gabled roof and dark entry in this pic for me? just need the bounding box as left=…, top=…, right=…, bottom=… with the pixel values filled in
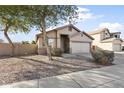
left=36, top=24, right=94, bottom=53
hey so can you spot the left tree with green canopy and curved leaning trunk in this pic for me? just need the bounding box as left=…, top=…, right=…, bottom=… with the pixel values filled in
left=0, top=6, right=30, bottom=56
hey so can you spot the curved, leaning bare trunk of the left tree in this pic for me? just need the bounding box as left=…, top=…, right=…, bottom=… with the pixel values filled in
left=4, top=26, right=15, bottom=56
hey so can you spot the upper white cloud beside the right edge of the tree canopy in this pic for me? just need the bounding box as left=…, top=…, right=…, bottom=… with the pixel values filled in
left=78, top=7, right=104, bottom=22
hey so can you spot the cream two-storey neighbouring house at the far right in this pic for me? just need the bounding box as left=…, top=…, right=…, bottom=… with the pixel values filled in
left=88, top=28, right=122, bottom=51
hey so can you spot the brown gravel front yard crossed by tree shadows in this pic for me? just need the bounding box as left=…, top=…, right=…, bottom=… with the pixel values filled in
left=0, top=55, right=102, bottom=85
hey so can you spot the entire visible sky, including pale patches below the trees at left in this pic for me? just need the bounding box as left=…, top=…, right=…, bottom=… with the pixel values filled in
left=0, top=5, right=124, bottom=42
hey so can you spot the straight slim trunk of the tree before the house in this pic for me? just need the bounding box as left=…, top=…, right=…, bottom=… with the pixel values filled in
left=42, top=20, right=52, bottom=61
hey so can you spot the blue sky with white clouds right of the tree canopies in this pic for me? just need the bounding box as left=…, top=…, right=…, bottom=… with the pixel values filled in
left=77, top=5, right=124, bottom=38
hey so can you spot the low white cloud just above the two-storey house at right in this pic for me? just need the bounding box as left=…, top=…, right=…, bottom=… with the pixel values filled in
left=99, top=22, right=124, bottom=32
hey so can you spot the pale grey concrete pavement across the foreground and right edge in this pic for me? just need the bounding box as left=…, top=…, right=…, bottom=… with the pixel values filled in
left=1, top=54, right=124, bottom=88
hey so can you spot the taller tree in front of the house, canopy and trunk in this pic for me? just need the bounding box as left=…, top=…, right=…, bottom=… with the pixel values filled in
left=25, top=5, right=78, bottom=60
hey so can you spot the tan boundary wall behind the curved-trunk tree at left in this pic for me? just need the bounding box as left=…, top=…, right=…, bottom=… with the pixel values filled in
left=0, top=43, right=37, bottom=56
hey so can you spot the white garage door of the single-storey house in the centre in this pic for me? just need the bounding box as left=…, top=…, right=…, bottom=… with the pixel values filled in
left=71, top=42, right=90, bottom=53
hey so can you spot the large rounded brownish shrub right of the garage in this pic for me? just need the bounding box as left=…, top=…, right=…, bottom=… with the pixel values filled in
left=91, top=47, right=114, bottom=65
